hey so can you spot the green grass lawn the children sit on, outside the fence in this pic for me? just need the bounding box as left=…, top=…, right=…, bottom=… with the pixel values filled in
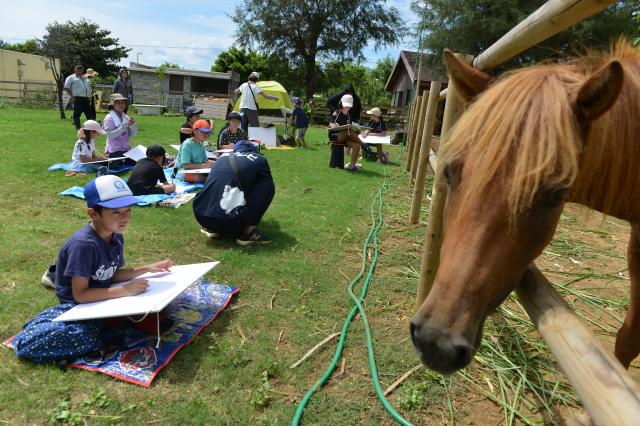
left=0, top=107, right=421, bottom=424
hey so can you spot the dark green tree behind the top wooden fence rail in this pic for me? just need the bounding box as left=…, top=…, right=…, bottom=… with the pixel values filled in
left=411, top=0, right=638, bottom=70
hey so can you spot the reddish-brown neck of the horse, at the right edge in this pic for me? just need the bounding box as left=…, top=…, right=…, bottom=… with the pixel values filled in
left=569, top=69, right=640, bottom=223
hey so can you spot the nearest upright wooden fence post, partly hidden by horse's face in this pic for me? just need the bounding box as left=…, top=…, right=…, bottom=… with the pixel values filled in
left=416, top=53, right=473, bottom=307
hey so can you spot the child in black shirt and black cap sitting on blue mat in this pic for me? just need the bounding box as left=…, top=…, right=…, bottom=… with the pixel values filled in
left=127, top=145, right=176, bottom=195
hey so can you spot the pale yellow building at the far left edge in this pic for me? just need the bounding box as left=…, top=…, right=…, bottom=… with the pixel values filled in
left=0, top=49, right=60, bottom=105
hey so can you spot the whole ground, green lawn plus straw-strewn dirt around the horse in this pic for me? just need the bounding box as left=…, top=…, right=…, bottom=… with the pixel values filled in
left=0, top=107, right=640, bottom=425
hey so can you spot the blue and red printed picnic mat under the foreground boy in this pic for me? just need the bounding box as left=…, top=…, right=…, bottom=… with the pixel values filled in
left=3, top=280, right=240, bottom=388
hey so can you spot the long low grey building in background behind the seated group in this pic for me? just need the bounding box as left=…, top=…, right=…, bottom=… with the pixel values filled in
left=128, top=63, right=240, bottom=117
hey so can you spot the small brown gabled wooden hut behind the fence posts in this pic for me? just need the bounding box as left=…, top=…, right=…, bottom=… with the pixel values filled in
left=384, top=50, right=448, bottom=107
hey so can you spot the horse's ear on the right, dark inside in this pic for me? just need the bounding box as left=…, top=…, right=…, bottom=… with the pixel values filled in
left=574, top=60, right=624, bottom=121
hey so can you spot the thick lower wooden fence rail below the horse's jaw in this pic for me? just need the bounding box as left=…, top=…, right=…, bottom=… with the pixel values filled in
left=516, top=264, right=640, bottom=425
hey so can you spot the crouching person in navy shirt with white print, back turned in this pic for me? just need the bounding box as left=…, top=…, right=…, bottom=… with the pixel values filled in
left=193, top=141, right=276, bottom=246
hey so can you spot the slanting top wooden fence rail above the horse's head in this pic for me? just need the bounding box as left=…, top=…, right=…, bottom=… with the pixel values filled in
left=473, top=0, right=616, bottom=70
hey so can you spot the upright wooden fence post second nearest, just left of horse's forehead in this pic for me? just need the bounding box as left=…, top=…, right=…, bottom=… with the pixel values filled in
left=409, top=81, right=442, bottom=224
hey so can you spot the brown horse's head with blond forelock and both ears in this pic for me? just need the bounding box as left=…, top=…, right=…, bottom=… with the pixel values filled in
left=411, top=52, right=623, bottom=374
